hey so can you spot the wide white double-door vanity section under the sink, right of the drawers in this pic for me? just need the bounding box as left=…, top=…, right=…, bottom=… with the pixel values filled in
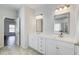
left=46, top=39, right=74, bottom=55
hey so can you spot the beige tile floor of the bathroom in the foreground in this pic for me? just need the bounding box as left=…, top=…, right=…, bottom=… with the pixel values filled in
left=0, top=47, right=40, bottom=55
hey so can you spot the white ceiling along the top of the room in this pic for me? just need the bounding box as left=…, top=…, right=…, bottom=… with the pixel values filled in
left=0, top=4, right=56, bottom=10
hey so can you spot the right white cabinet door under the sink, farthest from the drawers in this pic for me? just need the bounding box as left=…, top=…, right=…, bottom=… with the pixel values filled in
left=57, top=41, right=74, bottom=55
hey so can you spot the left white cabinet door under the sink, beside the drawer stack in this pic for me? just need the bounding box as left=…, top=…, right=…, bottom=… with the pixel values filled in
left=46, top=39, right=56, bottom=55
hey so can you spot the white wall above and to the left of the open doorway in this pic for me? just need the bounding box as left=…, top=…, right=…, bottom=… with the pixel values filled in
left=0, top=7, right=17, bottom=47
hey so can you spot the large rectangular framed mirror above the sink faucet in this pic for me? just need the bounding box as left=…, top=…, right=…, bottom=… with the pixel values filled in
left=54, top=13, right=70, bottom=34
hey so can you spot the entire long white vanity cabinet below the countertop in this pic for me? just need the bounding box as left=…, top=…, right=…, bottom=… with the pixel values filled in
left=29, top=36, right=75, bottom=55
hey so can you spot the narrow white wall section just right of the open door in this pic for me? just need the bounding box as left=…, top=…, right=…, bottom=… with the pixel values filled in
left=19, top=7, right=26, bottom=47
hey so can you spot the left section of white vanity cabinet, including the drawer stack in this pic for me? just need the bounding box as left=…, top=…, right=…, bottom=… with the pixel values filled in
left=29, top=36, right=46, bottom=54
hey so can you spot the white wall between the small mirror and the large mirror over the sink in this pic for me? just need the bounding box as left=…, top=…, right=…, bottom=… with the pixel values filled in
left=36, top=4, right=56, bottom=34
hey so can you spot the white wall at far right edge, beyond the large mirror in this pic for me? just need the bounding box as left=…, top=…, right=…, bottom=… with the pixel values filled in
left=73, top=4, right=79, bottom=42
